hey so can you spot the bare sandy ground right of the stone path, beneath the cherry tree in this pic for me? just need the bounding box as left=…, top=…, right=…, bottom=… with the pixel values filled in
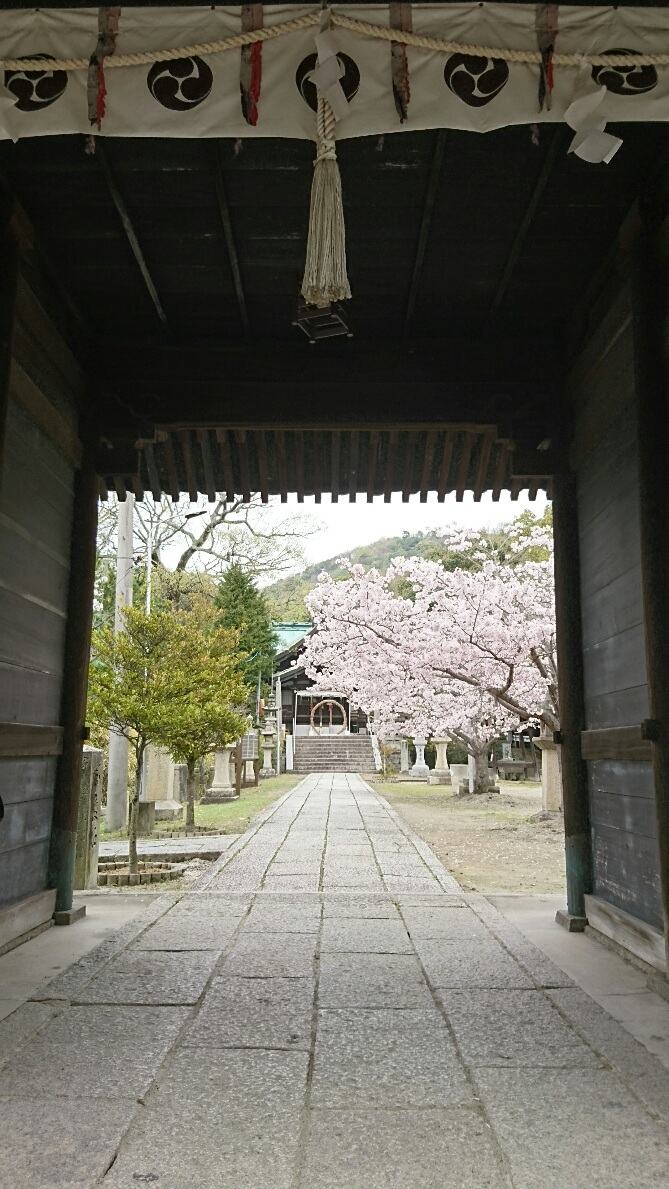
left=374, top=781, right=564, bottom=894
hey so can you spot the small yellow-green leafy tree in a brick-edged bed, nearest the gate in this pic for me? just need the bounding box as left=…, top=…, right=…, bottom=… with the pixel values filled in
left=88, top=608, right=245, bottom=874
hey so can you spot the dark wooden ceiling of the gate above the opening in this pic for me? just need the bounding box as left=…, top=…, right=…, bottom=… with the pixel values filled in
left=0, top=10, right=667, bottom=497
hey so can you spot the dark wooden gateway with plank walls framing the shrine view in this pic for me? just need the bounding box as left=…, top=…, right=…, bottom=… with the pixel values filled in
left=0, top=0, right=669, bottom=976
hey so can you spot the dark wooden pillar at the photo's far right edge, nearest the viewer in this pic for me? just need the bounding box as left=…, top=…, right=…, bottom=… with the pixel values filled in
left=632, top=223, right=669, bottom=970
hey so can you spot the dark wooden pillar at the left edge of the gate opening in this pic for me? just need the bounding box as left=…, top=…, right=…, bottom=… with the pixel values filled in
left=49, top=442, right=97, bottom=924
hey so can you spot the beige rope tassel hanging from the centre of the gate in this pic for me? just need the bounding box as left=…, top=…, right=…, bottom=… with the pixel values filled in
left=302, top=94, right=351, bottom=308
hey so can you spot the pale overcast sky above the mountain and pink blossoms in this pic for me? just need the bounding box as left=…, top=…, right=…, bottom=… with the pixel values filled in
left=264, top=491, right=545, bottom=562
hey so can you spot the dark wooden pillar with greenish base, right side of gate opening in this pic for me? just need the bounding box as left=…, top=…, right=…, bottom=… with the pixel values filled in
left=553, top=472, right=592, bottom=931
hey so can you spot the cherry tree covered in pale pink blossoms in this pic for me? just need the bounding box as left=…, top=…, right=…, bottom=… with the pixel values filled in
left=304, top=527, right=560, bottom=791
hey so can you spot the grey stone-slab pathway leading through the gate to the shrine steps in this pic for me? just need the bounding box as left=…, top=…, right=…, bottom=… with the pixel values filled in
left=0, top=774, right=669, bottom=1189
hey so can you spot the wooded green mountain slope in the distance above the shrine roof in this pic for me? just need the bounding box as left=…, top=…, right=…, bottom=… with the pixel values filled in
left=263, top=533, right=443, bottom=623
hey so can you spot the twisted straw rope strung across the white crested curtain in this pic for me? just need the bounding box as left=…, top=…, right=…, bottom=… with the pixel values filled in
left=5, top=10, right=669, bottom=71
